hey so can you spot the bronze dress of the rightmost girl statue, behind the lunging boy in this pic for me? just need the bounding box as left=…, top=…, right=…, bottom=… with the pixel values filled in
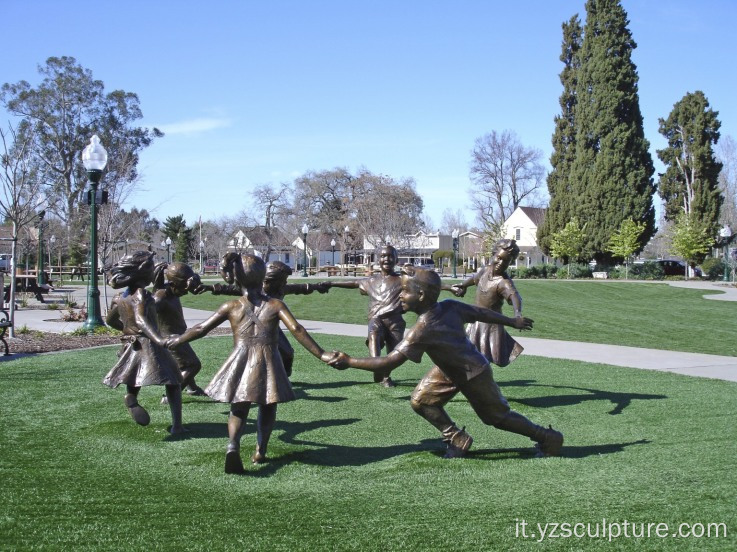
left=466, top=270, right=523, bottom=366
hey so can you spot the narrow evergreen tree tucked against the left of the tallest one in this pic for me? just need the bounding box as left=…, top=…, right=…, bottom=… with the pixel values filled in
left=537, top=14, right=583, bottom=254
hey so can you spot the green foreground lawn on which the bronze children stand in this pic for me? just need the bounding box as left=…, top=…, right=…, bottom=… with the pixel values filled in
left=0, top=334, right=737, bottom=551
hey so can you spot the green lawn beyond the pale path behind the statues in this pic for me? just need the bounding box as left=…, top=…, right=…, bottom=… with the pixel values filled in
left=182, top=279, right=737, bottom=356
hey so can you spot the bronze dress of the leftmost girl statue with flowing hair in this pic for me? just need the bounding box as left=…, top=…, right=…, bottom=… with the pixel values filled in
left=102, top=289, right=182, bottom=388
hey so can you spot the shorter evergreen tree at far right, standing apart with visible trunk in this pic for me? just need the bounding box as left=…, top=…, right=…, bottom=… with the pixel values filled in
left=658, top=90, right=724, bottom=236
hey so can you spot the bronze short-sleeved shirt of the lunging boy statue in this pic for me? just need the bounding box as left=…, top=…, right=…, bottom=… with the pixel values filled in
left=395, top=300, right=489, bottom=383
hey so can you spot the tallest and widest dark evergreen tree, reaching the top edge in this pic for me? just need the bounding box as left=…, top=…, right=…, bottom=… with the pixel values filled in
left=569, top=0, right=656, bottom=262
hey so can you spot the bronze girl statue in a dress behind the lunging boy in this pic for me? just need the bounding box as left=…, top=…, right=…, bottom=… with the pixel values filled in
left=451, top=239, right=523, bottom=366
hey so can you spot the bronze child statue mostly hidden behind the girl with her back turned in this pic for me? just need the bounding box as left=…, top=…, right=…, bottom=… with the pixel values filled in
left=195, top=253, right=328, bottom=377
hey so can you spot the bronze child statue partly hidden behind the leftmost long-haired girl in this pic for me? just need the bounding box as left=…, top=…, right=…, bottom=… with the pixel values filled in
left=154, top=262, right=205, bottom=403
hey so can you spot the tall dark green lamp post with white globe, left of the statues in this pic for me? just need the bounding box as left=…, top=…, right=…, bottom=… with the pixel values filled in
left=82, top=134, right=107, bottom=332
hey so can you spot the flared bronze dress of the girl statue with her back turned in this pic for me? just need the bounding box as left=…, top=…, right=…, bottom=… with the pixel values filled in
left=205, top=296, right=296, bottom=404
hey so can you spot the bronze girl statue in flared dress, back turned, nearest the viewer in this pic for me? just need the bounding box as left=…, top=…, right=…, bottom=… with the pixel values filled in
left=167, top=255, right=335, bottom=473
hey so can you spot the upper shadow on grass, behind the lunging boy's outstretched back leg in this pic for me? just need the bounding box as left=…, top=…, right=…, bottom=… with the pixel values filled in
left=497, top=380, right=668, bottom=416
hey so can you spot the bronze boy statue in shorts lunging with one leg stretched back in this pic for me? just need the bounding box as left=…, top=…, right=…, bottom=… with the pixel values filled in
left=330, top=265, right=563, bottom=458
